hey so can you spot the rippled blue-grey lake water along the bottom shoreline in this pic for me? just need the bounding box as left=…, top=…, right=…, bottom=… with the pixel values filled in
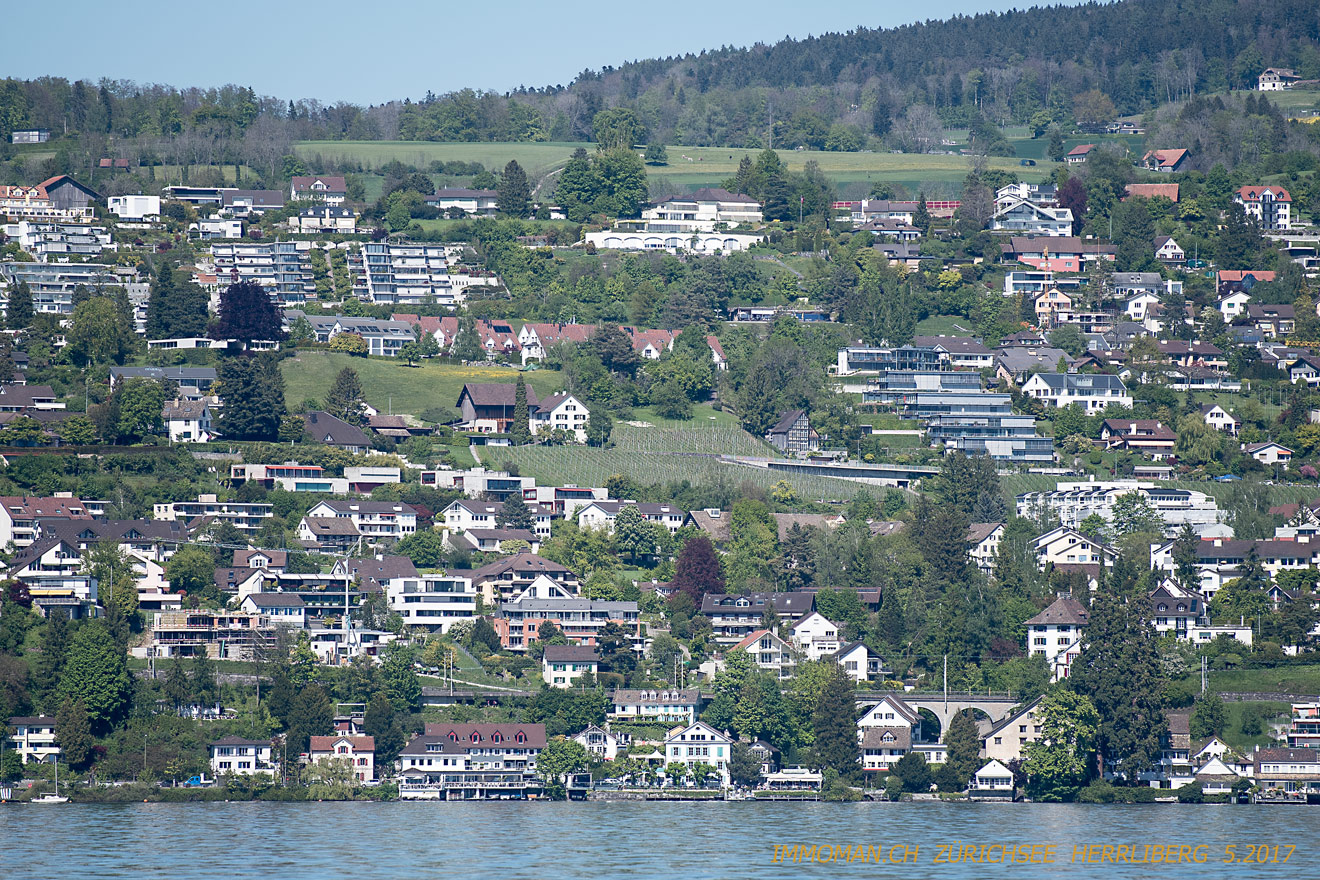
left=0, top=802, right=1320, bottom=880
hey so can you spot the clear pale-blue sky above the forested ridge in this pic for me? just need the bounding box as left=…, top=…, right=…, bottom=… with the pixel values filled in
left=0, top=0, right=1082, bottom=103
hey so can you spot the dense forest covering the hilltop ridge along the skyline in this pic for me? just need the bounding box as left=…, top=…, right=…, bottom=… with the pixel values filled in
left=0, top=0, right=1320, bottom=168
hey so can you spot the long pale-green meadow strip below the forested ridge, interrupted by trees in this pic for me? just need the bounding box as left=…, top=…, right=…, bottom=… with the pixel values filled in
left=294, top=141, right=1019, bottom=195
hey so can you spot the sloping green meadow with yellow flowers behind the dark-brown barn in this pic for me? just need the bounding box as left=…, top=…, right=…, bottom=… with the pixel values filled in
left=280, top=351, right=560, bottom=417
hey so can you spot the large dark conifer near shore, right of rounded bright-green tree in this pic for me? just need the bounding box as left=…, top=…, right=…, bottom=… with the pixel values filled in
left=1069, top=590, right=1166, bottom=785
